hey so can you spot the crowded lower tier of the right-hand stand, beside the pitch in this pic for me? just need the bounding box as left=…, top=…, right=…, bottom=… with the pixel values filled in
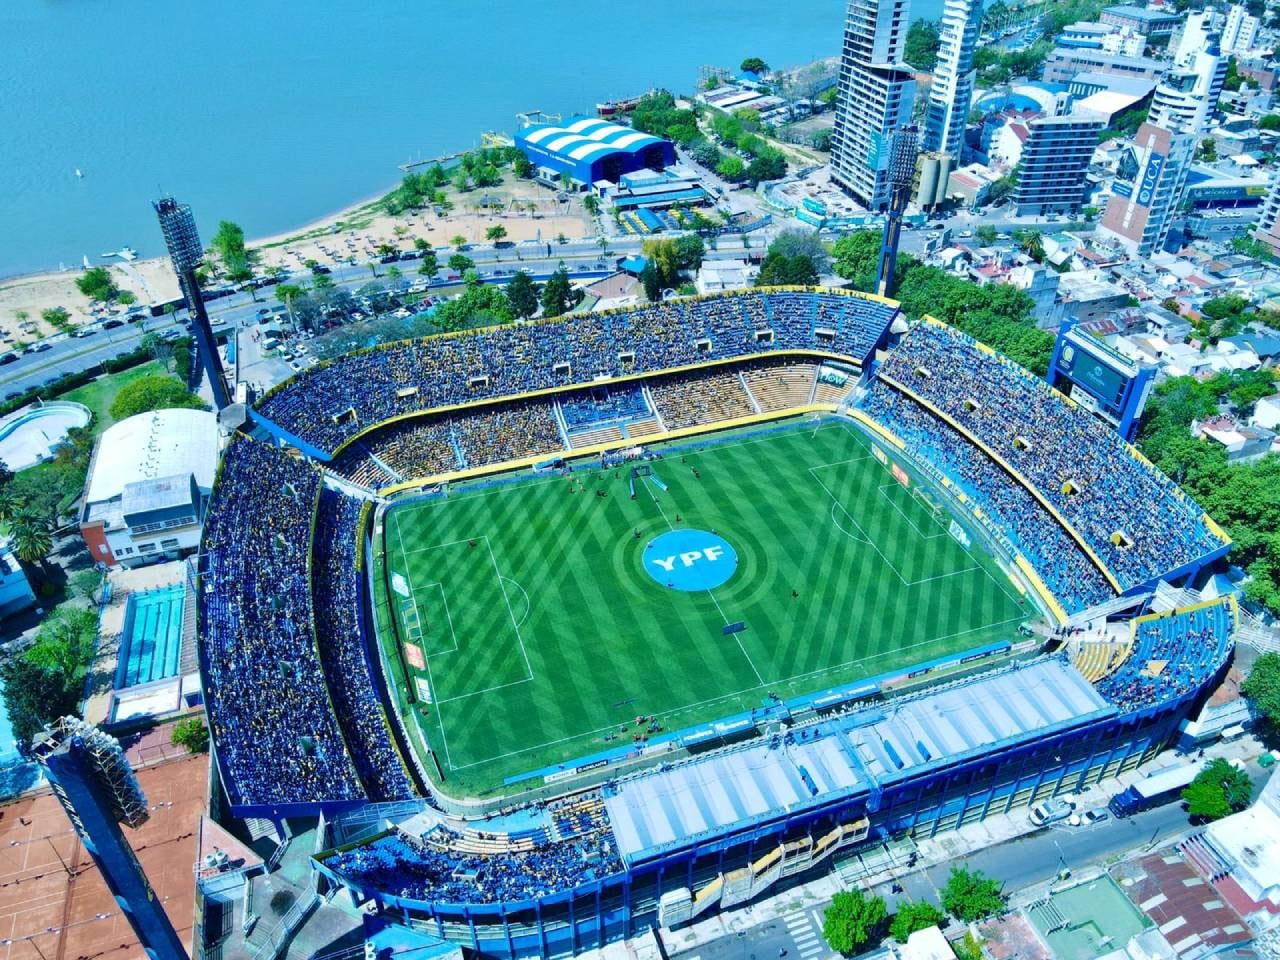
left=858, top=381, right=1115, bottom=613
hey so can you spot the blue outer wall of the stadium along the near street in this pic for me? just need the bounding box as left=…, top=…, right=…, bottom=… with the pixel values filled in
left=312, top=671, right=1221, bottom=957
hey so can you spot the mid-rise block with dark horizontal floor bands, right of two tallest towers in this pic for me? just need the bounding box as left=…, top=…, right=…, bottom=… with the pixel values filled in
left=1014, top=114, right=1106, bottom=216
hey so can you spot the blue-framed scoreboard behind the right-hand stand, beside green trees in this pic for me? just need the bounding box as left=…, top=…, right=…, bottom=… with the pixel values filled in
left=1047, top=326, right=1155, bottom=440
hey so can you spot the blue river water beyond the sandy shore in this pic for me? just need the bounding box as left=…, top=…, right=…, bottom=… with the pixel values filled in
left=0, top=0, right=941, bottom=276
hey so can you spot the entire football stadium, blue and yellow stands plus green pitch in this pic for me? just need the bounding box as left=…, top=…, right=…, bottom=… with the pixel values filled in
left=196, top=288, right=1238, bottom=956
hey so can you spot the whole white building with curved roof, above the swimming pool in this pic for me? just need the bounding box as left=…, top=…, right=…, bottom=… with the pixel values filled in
left=79, top=410, right=220, bottom=567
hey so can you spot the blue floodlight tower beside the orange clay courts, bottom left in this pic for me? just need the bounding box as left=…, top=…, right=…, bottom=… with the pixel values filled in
left=33, top=717, right=187, bottom=960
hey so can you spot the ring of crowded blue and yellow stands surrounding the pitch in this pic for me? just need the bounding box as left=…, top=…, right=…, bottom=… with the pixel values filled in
left=198, top=289, right=1235, bottom=954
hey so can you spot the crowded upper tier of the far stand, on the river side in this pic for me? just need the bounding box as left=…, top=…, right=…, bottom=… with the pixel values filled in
left=247, top=289, right=896, bottom=451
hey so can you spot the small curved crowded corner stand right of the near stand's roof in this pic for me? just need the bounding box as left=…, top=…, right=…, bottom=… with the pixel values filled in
left=1094, top=598, right=1235, bottom=712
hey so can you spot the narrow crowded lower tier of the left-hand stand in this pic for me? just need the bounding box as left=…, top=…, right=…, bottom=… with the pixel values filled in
left=311, top=489, right=413, bottom=803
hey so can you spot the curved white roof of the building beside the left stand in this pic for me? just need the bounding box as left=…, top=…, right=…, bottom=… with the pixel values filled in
left=84, top=410, right=218, bottom=504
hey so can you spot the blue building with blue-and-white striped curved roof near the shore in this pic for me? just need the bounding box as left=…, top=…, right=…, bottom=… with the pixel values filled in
left=516, top=116, right=676, bottom=189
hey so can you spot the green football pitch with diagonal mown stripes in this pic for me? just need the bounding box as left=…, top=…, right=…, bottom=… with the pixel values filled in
left=375, top=420, right=1034, bottom=795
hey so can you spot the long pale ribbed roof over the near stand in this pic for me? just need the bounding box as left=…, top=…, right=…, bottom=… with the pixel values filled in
left=604, top=659, right=1114, bottom=863
